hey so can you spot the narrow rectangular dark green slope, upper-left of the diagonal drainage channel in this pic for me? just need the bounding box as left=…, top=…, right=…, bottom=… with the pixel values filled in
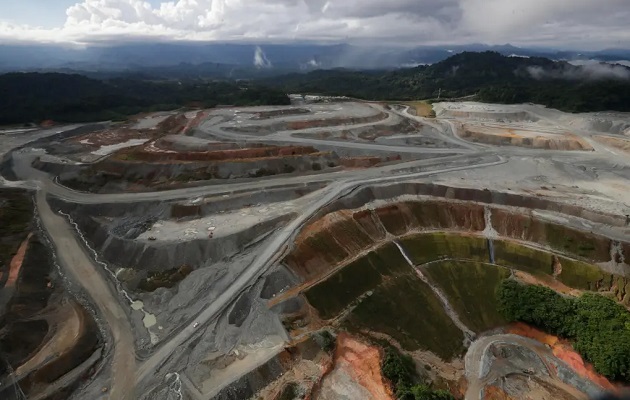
left=305, top=243, right=411, bottom=319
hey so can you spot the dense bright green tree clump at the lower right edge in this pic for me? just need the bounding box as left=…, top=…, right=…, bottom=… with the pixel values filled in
left=497, top=280, right=630, bottom=383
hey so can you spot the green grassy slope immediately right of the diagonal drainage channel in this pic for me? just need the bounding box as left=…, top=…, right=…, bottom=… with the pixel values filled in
left=425, top=261, right=510, bottom=333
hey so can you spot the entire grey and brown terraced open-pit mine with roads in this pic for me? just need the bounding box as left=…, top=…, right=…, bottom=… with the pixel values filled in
left=0, top=100, right=630, bottom=400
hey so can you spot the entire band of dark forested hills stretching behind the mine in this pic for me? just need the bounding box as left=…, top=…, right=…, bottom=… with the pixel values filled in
left=0, top=51, right=630, bottom=124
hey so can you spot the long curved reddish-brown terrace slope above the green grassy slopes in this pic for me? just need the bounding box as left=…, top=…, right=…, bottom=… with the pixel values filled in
left=284, top=195, right=630, bottom=290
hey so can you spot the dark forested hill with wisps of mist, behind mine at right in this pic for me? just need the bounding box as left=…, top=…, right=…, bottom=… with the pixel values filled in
left=267, top=52, right=630, bottom=112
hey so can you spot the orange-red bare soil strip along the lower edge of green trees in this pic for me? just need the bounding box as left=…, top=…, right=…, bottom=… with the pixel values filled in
left=508, top=323, right=619, bottom=392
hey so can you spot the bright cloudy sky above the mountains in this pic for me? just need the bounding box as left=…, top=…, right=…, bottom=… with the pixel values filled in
left=0, top=0, right=630, bottom=49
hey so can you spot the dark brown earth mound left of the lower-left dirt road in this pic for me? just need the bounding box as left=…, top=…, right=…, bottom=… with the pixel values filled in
left=0, top=235, right=100, bottom=398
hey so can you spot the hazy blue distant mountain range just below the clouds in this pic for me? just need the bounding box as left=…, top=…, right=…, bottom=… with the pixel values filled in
left=0, top=43, right=630, bottom=79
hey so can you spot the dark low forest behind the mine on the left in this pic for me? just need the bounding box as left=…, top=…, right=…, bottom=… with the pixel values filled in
left=0, top=73, right=289, bottom=124
